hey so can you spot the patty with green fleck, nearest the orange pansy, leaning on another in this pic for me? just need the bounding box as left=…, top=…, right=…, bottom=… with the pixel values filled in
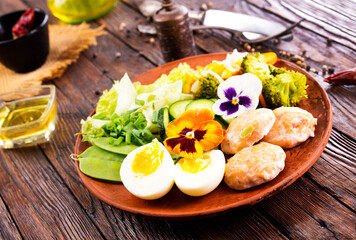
left=221, top=108, right=276, bottom=154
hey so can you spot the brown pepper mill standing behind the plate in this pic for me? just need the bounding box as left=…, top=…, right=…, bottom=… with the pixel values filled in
left=153, top=0, right=195, bottom=62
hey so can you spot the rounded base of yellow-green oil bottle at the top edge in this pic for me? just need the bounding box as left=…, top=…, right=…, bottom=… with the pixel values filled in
left=47, top=0, right=117, bottom=23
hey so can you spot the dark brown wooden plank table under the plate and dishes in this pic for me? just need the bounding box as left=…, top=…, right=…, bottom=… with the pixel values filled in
left=0, top=0, right=356, bottom=239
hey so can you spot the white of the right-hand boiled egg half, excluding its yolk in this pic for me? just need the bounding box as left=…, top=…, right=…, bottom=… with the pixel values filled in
left=174, top=150, right=225, bottom=197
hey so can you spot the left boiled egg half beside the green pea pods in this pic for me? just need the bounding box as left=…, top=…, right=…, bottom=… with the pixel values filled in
left=120, top=139, right=174, bottom=200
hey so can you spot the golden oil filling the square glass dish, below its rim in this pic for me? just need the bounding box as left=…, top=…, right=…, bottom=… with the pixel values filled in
left=0, top=96, right=57, bottom=148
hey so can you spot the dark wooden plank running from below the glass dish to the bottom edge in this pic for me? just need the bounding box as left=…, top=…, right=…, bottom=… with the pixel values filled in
left=0, top=147, right=102, bottom=239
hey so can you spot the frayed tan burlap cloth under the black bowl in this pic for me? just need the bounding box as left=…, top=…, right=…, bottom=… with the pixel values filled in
left=0, top=23, right=106, bottom=94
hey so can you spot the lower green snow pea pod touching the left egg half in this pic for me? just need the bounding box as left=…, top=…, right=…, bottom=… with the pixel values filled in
left=78, top=146, right=126, bottom=182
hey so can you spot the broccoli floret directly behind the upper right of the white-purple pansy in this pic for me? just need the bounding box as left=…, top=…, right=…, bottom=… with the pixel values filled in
left=241, top=52, right=271, bottom=83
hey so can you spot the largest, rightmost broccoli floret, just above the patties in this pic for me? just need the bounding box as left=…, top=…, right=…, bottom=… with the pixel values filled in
left=262, top=68, right=308, bottom=108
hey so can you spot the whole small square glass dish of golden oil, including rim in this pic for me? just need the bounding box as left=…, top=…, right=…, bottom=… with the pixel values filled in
left=0, top=85, right=57, bottom=149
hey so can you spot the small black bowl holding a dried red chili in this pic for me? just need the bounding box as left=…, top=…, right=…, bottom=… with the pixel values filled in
left=0, top=8, right=49, bottom=73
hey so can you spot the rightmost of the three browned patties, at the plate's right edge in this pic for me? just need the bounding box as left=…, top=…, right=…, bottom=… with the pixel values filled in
left=262, top=107, right=317, bottom=149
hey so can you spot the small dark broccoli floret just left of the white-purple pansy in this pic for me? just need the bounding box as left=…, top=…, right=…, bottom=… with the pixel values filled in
left=195, top=74, right=220, bottom=99
